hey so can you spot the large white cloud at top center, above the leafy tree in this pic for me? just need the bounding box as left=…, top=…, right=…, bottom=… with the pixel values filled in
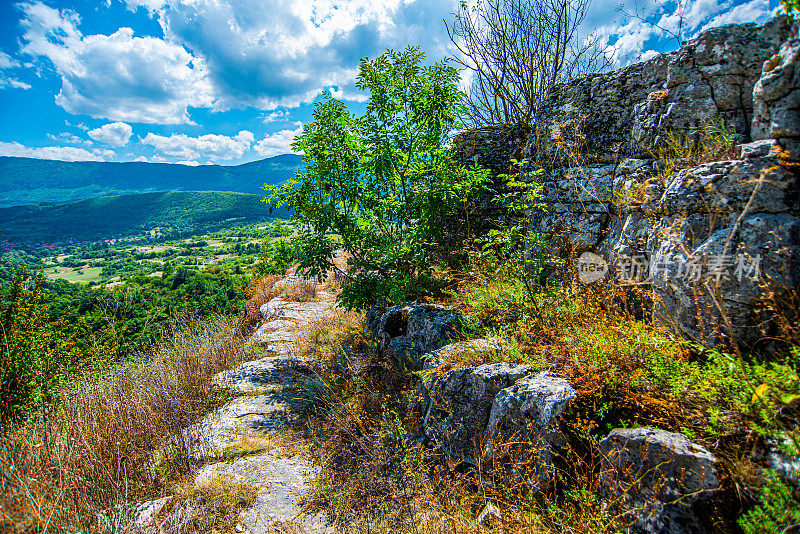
left=128, top=0, right=456, bottom=110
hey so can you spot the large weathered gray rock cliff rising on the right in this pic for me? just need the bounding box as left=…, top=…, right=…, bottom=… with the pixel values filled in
left=454, top=18, right=800, bottom=346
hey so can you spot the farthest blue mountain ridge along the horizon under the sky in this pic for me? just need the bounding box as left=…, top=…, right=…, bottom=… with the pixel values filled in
left=0, top=154, right=302, bottom=208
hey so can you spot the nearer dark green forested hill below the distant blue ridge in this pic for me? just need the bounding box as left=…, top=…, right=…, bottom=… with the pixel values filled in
left=0, top=191, right=288, bottom=243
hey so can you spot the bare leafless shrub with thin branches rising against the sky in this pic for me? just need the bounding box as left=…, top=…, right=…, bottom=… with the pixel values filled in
left=447, top=0, right=609, bottom=125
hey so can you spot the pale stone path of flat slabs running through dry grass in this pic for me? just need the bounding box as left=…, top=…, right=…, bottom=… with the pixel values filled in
left=131, top=275, right=335, bottom=534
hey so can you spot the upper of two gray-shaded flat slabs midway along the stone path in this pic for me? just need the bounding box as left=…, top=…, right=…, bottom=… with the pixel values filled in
left=213, top=356, right=307, bottom=393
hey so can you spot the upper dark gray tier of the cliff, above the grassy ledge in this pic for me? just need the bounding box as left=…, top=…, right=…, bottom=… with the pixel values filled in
left=525, top=18, right=790, bottom=169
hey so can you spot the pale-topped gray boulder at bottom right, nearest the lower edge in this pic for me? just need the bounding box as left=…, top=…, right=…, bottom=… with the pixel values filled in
left=600, top=427, right=719, bottom=534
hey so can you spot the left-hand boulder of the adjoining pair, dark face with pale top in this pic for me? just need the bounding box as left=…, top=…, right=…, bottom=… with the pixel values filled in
left=423, top=363, right=533, bottom=465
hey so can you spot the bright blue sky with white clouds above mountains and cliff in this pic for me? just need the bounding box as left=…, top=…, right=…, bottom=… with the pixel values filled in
left=0, top=0, right=777, bottom=165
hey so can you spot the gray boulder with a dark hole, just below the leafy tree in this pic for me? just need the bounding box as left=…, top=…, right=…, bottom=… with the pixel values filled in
left=367, top=302, right=461, bottom=371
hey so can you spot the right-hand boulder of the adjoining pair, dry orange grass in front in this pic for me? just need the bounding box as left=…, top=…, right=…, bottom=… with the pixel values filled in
left=483, top=372, right=575, bottom=491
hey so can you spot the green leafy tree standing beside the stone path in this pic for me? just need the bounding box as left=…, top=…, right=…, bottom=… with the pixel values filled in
left=266, top=47, right=487, bottom=308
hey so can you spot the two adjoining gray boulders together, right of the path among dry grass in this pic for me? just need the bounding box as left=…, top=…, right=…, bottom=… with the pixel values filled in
left=421, top=360, right=575, bottom=491
